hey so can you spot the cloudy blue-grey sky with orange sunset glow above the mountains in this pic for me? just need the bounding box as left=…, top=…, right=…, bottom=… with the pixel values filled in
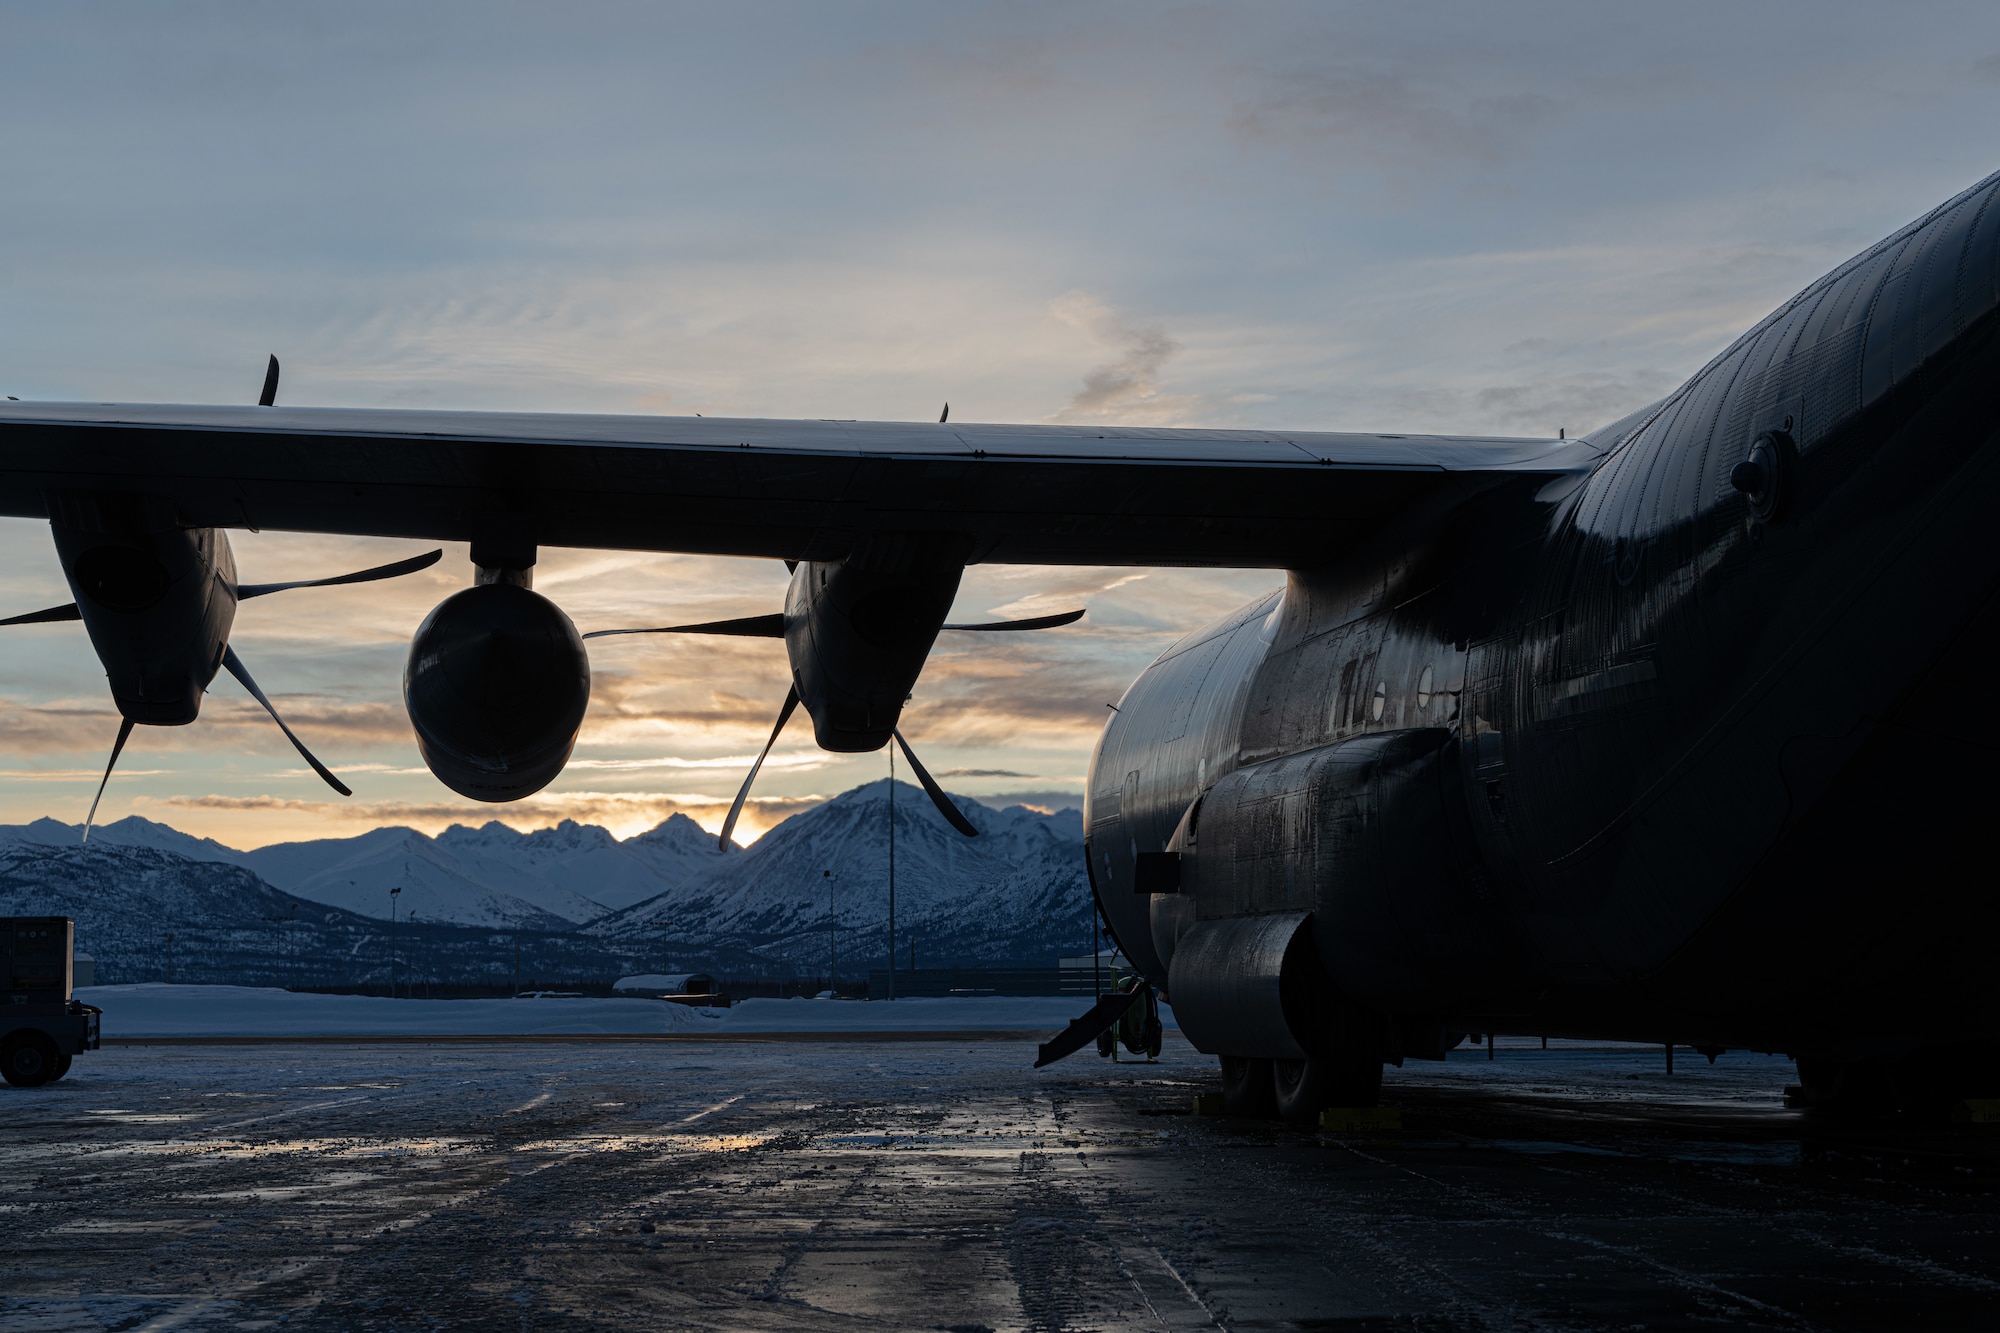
left=0, top=0, right=2000, bottom=847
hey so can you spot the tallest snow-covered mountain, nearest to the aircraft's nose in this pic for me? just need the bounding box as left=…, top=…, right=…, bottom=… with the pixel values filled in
left=586, top=779, right=1090, bottom=973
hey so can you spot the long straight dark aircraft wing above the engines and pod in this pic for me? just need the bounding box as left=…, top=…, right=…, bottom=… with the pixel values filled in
left=0, top=402, right=1596, bottom=568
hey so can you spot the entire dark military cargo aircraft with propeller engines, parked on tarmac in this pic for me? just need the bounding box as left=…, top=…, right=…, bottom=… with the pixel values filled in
left=0, top=176, right=2000, bottom=1117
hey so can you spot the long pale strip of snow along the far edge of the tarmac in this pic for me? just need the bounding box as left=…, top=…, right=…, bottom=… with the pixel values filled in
left=76, top=983, right=1172, bottom=1037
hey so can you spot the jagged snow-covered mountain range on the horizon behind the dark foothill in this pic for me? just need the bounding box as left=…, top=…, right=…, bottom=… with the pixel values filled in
left=0, top=781, right=1090, bottom=975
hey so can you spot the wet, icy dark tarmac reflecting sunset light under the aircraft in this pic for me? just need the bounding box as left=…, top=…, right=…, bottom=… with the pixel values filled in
left=0, top=1041, right=2000, bottom=1333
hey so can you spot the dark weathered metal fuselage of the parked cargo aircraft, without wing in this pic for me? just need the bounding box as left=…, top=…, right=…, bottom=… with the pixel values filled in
left=1086, top=178, right=2000, bottom=1059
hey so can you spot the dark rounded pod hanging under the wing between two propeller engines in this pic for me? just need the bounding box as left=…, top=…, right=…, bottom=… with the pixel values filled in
left=402, top=582, right=590, bottom=801
